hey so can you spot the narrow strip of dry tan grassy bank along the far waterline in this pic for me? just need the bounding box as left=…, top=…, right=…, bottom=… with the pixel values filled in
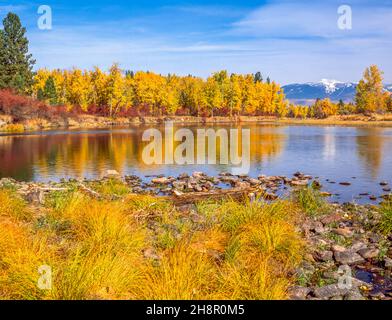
left=0, top=114, right=392, bottom=134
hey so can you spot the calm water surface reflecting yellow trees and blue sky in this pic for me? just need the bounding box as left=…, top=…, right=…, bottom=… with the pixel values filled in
left=0, top=124, right=392, bottom=202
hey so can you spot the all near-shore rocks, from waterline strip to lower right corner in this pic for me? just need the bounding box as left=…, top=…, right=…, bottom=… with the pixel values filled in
left=0, top=170, right=392, bottom=300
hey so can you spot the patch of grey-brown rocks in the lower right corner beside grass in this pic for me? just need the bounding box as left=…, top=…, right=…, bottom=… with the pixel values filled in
left=290, top=204, right=392, bottom=300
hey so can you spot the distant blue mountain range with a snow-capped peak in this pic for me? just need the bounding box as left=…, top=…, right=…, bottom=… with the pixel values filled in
left=283, top=79, right=392, bottom=105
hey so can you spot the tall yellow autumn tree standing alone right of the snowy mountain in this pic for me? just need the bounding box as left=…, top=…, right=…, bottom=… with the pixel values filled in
left=355, top=65, right=387, bottom=113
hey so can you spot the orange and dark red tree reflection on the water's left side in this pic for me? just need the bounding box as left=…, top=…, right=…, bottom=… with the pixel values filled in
left=0, top=126, right=285, bottom=180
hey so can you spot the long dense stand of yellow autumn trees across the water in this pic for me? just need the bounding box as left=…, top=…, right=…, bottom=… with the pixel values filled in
left=33, top=64, right=287, bottom=116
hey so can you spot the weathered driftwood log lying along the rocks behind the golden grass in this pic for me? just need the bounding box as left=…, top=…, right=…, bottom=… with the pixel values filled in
left=162, top=188, right=277, bottom=206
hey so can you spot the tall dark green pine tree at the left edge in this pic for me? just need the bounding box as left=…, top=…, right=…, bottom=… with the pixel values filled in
left=0, top=13, right=35, bottom=93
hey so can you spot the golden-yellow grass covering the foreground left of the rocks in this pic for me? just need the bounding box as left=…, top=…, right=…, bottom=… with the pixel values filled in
left=0, top=190, right=303, bottom=300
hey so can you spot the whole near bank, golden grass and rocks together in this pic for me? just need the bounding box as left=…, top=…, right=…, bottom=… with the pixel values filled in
left=0, top=172, right=392, bottom=300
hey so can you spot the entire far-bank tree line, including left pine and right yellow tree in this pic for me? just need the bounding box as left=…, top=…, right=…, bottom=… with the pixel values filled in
left=0, top=13, right=392, bottom=118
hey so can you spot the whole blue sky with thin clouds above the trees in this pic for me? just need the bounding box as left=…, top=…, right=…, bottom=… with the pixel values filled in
left=0, top=0, right=392, bottom=84
